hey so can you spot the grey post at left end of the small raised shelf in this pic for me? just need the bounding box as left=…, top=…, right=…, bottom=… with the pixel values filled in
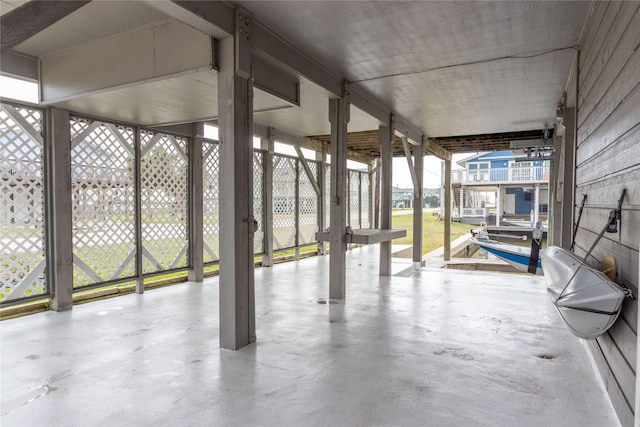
left=329, top=98, right=350, bottom=300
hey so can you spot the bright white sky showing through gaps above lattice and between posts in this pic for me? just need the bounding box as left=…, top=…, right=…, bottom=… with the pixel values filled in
left=0, top=76, right=471, bottom=188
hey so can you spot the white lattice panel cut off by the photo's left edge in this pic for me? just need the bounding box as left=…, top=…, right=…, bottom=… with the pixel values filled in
left=0, top=103, right=47, bottom=302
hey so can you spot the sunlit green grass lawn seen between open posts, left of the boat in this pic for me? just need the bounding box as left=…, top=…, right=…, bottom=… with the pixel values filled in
left=391, top=212, right=472, bottom=254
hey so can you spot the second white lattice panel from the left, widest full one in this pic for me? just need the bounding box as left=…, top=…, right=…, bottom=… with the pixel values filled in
left=71, top=117, right=136, bottom=287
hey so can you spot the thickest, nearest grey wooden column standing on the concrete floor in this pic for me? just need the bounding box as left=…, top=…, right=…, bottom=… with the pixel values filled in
left=218, top=10, right=256, bottom=350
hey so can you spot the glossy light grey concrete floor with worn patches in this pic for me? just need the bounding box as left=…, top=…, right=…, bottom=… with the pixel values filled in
left=0, top=246, right=619, bottom=426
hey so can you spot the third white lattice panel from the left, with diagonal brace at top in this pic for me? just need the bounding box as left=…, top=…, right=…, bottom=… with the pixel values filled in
left=140, top=130, right=188, bottom=273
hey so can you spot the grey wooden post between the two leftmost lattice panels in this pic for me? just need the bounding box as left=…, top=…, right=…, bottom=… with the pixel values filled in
left=45, top=108, right=73, bottom=311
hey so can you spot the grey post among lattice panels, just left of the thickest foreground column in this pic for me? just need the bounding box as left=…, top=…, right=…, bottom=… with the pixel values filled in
left=188, top=123, right=204, bottom=282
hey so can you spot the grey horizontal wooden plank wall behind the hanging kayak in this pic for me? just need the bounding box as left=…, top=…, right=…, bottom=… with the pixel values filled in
left=570, top=1, right=640, bottom=426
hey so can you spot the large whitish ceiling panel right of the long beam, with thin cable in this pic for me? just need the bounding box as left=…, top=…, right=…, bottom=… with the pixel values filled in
left=241, top=1, right=588, bottom=136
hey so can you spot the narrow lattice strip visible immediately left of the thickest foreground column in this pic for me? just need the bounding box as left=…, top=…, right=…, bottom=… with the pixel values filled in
left=202, top=141, right=220, bottom=263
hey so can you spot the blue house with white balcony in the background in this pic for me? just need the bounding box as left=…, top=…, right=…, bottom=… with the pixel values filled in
left=452, top=150, right=550, bottom=225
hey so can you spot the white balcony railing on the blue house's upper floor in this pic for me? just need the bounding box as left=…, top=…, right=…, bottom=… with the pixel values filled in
left=451, top=166, right=549, bottom=184
